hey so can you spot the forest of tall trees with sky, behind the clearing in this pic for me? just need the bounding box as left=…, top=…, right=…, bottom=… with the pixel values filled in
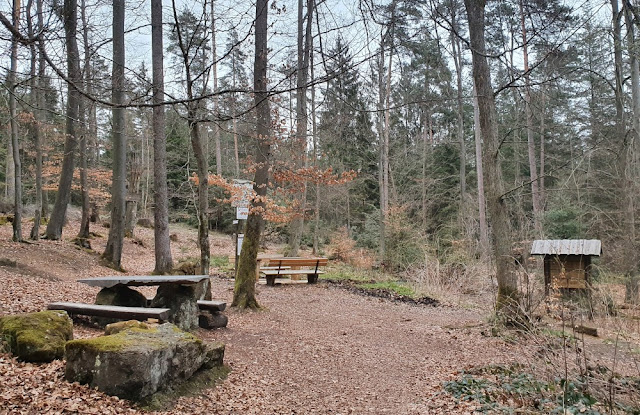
left=0, top=0, right=640, bottom=312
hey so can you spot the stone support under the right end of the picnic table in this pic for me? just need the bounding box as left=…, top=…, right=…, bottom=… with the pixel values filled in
left=151, top=284, right=198, bottom=330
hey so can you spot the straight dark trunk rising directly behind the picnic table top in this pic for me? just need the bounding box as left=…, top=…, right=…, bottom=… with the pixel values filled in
left=151, top=0, right=173, bottom=274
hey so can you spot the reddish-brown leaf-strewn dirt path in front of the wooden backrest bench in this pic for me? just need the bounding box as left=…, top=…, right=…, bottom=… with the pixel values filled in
left=181, top=283, right=513, bottom=414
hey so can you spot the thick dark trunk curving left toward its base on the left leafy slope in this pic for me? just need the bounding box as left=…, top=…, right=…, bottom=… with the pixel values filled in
left=45, top=0, right=81, bottom=240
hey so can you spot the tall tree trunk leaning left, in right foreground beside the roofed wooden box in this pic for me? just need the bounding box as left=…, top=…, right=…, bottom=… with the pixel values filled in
left=464, top=0, right=522, bottom=323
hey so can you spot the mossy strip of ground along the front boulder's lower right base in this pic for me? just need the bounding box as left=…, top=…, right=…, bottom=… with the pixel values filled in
left=141, top=366, right=231, bottom=411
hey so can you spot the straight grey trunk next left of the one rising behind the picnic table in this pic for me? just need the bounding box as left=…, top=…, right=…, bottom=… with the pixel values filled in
left=102, top=0, right=127, bottom=270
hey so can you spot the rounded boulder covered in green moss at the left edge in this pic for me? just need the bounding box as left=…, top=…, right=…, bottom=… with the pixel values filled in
left=0, top=310, right=73, bottom=362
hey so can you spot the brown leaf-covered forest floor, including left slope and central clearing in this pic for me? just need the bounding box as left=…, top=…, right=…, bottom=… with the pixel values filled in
left=0, top=213, right=637, bottom=414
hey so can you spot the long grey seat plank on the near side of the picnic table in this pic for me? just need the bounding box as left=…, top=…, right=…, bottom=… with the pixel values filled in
left=47, top=302, right=171, bottom=320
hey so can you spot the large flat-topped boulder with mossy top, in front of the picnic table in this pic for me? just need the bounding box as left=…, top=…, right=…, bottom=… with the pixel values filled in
left=65, top=323, right=224, bottom=400
